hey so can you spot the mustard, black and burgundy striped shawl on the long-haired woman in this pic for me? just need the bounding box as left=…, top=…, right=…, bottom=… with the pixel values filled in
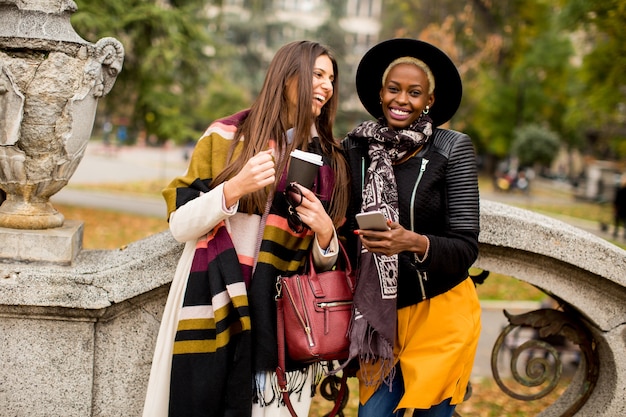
left=163, top=112, right=334, bottom=416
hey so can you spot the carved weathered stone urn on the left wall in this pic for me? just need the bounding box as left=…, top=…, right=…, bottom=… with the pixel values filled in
left=0, top=0, right=124, bottom=230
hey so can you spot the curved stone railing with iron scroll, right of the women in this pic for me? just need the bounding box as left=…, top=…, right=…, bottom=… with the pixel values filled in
left=475, top=201, right=626, bottom=417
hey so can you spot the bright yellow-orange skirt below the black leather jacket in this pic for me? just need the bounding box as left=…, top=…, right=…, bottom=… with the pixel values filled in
left=359, top=278, right=481, bottom=409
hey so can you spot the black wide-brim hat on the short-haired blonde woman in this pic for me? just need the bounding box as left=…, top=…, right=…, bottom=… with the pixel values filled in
left=356, top=38, right=463, bottom=126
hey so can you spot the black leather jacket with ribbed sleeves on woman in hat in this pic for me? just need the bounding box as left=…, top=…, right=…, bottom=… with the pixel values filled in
left=340, top=129, right=480, bottom=308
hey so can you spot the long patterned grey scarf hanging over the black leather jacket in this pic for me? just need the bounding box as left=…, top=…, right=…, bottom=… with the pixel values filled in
left=348, top=114, right=432, bottom=385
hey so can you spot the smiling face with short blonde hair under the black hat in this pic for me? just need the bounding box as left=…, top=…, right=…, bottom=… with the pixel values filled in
left=380, top=63, right=435, bottom=130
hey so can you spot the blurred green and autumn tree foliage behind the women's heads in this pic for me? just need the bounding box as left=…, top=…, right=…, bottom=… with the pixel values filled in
left=67, top=0, right=626, bottom=158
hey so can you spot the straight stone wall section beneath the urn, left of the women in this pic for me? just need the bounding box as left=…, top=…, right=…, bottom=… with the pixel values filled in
left=0, top=232, right=182, bottom=417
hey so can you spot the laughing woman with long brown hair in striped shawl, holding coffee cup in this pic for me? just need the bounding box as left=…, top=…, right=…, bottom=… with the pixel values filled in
left=144, top=41, right=348, bottom=417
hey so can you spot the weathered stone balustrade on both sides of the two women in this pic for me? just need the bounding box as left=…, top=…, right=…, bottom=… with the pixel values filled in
left=0, top=201, right=626, bottom=417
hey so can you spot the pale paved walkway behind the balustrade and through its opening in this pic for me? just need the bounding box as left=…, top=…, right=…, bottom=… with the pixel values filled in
left=51, top=143, right=609, bottom=376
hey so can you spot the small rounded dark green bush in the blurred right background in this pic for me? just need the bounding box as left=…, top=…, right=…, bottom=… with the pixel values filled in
left=511, top=124, right=560, bottom=166
